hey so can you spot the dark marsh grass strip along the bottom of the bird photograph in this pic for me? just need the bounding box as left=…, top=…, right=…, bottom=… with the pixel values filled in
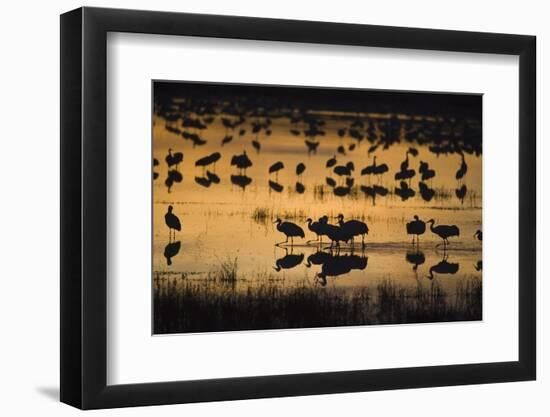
left=154, top=260, right=482, bottom=334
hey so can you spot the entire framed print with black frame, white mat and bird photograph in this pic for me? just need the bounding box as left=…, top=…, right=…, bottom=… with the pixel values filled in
left=61, top=8, right=536, bottom=409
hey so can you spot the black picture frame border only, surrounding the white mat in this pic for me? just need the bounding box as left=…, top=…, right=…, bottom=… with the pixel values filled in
left=60, top=7, right=536, bottom=409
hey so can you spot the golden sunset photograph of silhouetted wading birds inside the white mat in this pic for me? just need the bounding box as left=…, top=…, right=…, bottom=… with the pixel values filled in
left=151, top=80, right=483, bottom=334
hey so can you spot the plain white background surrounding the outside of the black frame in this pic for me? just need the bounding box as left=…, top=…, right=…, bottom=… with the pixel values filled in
left=0, top=0, right=550, bottom=417
